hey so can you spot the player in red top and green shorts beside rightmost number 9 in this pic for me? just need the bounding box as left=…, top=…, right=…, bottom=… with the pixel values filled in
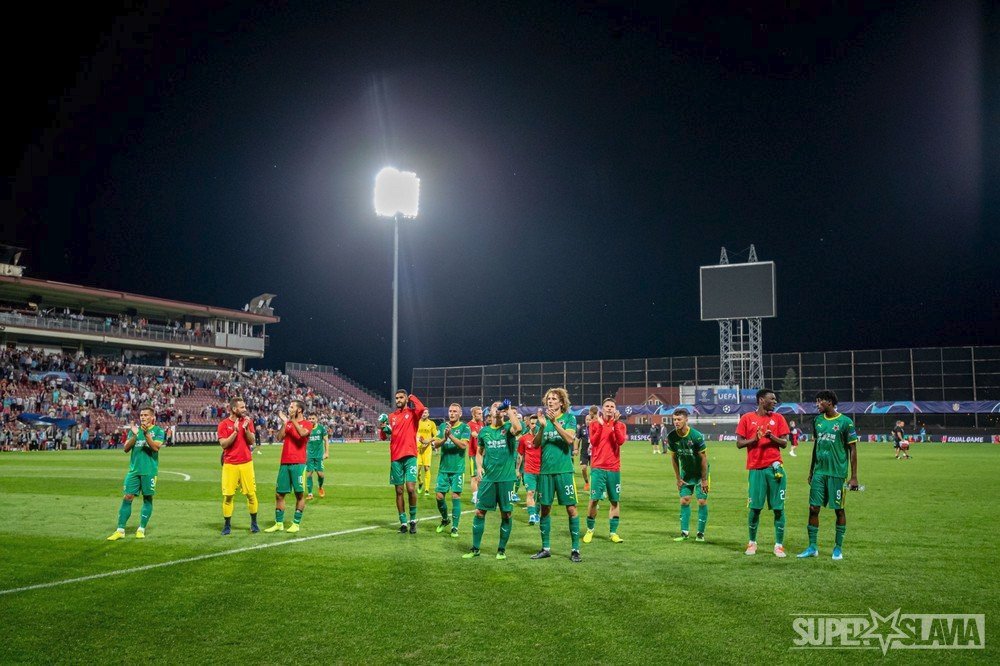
left=736, top=389, right=788, bottom=557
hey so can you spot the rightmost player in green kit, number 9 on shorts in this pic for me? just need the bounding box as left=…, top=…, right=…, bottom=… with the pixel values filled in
left=799, top=391, right=858, bottom=560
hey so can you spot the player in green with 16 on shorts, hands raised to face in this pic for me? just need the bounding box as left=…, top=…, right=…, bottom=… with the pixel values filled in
left=462, top=401, right=522, bottom=560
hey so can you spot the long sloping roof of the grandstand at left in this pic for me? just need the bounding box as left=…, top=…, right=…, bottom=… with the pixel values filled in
left=0, top=275, right=279, bottom=324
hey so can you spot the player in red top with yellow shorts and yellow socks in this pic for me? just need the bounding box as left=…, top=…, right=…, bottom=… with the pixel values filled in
left=216, top=397, right=260, bottom=536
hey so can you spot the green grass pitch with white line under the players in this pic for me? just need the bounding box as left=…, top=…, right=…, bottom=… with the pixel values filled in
left=0, top=442, right=1000, bottom=664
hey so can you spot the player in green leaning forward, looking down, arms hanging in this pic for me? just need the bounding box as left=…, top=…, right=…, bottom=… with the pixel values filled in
left=667, top=407, right=711, bottom=541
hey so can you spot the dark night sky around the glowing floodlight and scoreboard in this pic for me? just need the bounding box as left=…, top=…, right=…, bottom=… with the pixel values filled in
left=0, top=1, right=1000, bottom=391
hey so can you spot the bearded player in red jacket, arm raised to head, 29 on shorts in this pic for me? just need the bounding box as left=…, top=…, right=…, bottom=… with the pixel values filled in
left=378, top=389, right=427, bottom=534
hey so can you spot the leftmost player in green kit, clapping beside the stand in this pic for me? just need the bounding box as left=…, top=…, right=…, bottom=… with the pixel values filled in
left=108, top=404, right=165, bottom=541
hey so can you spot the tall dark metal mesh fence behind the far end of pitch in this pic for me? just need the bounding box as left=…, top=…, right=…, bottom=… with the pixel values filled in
left=411, top=346, right=1000, bottom=427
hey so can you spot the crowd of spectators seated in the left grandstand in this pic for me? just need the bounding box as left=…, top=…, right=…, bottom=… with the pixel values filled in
left=0, top=348, right=374, bottom=451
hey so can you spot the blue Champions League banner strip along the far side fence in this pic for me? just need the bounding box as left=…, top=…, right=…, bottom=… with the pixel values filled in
left=430, top=400, right=1000, bottom=419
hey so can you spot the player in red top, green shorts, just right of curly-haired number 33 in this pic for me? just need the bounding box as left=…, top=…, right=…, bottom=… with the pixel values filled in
left=583, top=398, right=626, bottom=543
